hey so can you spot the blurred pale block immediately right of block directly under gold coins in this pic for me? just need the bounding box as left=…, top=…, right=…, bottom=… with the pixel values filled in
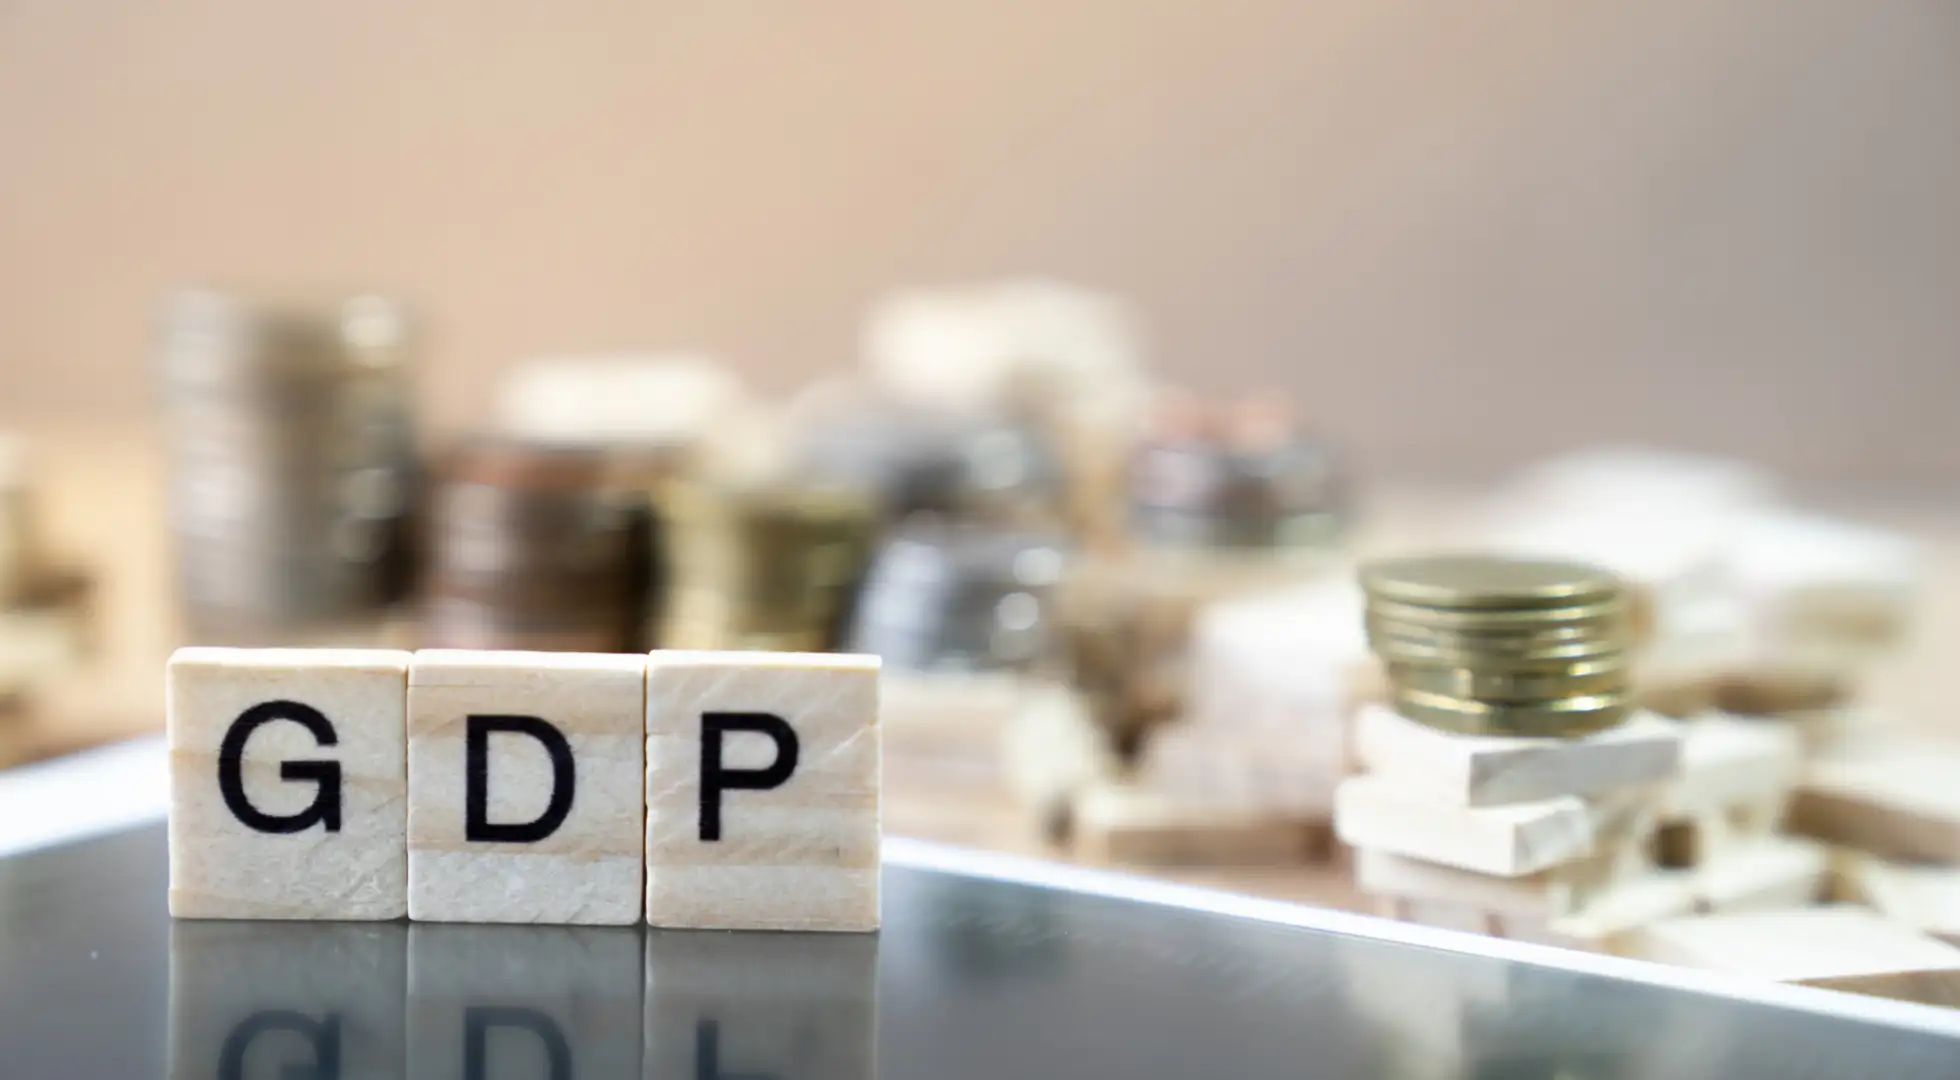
left=1660, top=713, right=1803, bottom=825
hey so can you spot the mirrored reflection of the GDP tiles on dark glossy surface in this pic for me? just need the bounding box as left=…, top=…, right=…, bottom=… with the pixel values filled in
left=169, top=921, right=878, bottom=1080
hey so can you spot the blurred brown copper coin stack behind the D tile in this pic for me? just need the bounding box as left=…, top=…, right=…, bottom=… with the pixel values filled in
left=421, top=439, right=659, bottom=653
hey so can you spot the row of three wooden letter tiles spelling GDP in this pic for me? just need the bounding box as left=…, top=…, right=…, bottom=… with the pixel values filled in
left=165, top=649, right=878, bottom=931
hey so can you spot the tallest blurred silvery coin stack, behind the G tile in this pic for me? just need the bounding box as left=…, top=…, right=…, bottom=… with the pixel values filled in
left=159, top=292, right=416, bottom=643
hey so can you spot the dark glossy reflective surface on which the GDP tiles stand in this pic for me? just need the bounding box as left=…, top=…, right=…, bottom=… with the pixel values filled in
left=0, top=827, right=1960, bottom=1080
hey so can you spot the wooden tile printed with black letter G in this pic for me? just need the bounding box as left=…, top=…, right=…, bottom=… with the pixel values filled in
left=165, top=649, right=410, bottom=919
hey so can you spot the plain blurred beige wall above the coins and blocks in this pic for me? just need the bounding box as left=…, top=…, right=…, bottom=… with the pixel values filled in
left=0, top=0, right=1960, bottom=492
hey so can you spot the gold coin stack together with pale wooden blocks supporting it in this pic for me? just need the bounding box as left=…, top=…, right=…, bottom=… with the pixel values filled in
left=1335, top=555, right=1693, bottom=949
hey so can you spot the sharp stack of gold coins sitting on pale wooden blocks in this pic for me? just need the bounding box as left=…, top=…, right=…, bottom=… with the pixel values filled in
left=1360, top=555, right=1633, bottom=737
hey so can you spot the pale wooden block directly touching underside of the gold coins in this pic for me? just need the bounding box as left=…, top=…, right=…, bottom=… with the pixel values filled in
left=1354, top=706, right=1682, bottom=806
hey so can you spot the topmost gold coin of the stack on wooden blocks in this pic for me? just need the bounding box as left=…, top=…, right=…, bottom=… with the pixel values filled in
left=1360, top=555, right=1623, bottom=608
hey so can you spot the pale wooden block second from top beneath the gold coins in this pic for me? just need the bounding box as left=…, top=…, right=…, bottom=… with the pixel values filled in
left=1335, top=776, right=1631, bottom=878
